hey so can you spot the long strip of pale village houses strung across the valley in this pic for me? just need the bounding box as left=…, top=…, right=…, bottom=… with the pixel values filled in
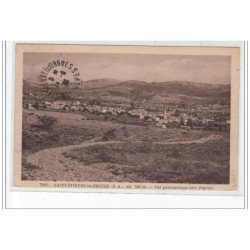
left=25, top=101, right=230, bottom=131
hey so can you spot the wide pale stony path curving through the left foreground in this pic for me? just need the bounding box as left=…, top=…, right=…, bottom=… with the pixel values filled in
left=26, top=140, right=122, bottom=181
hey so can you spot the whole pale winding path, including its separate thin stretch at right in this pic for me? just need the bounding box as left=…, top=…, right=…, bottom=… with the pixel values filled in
left=26, top=134, right=222, bottom=182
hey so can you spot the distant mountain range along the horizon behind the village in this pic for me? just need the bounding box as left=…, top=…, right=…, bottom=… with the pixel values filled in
left=23, top=78, right=231, bottom=105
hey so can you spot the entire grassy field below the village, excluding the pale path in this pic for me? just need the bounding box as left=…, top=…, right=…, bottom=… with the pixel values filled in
left=23, top=110, right=230, bottom=184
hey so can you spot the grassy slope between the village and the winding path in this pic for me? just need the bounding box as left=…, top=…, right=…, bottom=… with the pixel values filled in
left=23, top=110, right=211, bottom=155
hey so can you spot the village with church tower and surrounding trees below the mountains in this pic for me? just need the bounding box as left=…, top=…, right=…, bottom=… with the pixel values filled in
left=24, top=100, right=230, bottom=131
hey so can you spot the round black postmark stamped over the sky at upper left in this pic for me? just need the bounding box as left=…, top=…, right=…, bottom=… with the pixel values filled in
left=40, top=60, right=81, bottom=87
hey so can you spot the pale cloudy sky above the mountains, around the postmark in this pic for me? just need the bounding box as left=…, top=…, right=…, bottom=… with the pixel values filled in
left=23, top=52, right=231, bottom=84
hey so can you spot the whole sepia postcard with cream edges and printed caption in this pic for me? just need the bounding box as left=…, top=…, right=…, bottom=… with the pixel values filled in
left=13, top=43, right=240, bottom=192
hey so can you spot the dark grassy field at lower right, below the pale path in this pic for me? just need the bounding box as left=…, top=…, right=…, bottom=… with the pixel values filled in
left=64, top=138, right=229, bottom=184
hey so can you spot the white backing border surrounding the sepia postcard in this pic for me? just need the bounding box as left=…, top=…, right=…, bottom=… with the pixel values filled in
left=6, top=41, right=245, bottom=208
